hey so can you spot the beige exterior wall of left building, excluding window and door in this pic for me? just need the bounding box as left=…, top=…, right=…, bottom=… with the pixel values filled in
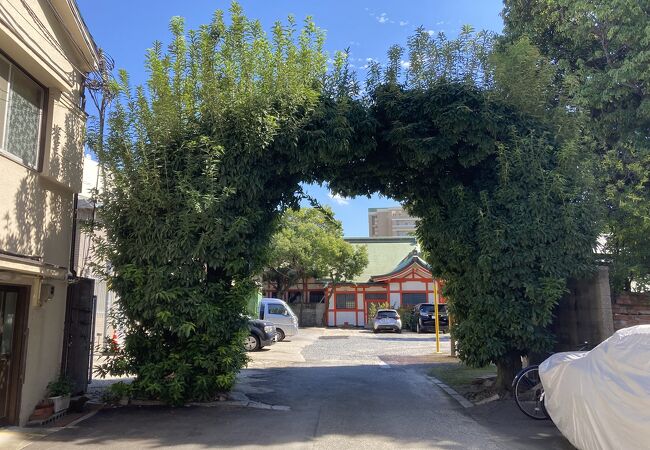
left=0, top=0, right=93, bottom=425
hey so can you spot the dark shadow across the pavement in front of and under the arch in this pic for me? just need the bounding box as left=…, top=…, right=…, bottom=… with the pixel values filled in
left=27, top=364, right=571, bottom=450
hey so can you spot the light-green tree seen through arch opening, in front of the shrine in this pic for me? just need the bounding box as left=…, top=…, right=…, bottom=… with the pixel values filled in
left=263, top=207, right=368, bottom=294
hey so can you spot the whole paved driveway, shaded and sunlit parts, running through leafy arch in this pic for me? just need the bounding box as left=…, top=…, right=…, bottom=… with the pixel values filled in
left=22, top=329, right=566, bottom=449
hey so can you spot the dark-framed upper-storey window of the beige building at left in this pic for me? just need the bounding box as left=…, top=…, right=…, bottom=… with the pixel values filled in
left=0, top=56, right=45, bottom=169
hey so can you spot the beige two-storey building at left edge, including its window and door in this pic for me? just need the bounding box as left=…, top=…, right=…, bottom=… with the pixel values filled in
left=0, top=0, right=98, bottom=425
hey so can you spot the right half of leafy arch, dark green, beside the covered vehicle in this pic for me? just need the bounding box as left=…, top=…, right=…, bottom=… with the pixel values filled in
left=326, top=28, right=598, bottom=388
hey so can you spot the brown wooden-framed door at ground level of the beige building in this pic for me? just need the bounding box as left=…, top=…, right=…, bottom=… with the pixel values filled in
left=0, top=285, right=28, bottom=424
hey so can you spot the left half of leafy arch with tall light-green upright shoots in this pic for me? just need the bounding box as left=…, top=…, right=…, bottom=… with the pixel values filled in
left=97, top=3, right=326, bottom=405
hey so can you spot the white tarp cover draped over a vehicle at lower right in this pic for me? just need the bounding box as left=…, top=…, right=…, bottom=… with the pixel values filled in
left=539, top=325, right=650, bottom=450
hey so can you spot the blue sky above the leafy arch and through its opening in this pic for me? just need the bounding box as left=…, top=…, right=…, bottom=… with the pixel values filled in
left=77, top=0, right=503, bottom=236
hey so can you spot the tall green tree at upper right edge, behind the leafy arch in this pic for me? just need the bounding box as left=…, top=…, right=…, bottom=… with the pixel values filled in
left=503, top=0, right=650, bottom=290
